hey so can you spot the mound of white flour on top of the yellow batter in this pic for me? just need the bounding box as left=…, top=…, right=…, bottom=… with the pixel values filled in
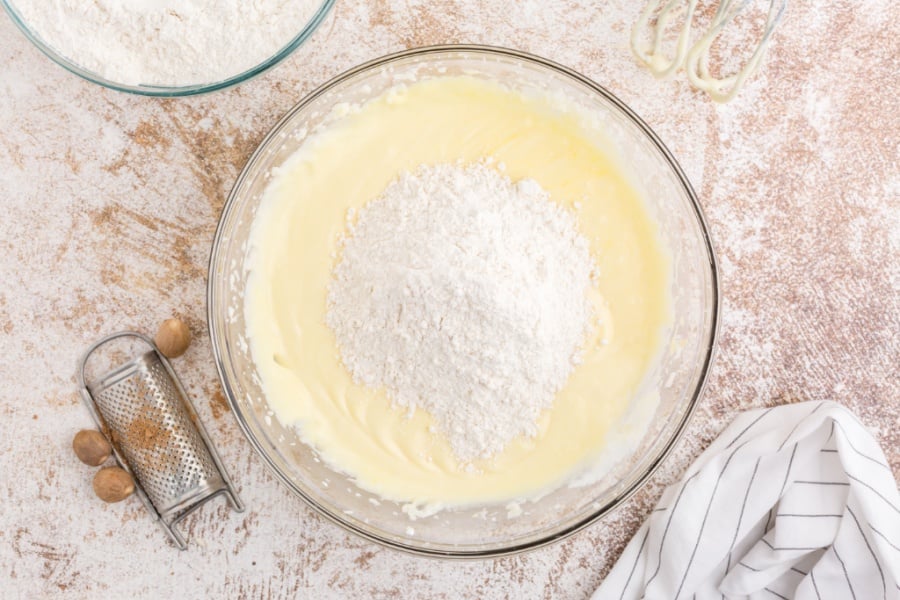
left=326, top=163, right=596, bottom=463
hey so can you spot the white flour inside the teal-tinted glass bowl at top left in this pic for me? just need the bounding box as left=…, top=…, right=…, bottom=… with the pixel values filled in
left=12, top=0, right=322, bottom=86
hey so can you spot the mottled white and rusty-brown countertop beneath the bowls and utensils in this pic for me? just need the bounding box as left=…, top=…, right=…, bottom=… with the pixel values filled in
left=0, top=0, right=900, bottom=598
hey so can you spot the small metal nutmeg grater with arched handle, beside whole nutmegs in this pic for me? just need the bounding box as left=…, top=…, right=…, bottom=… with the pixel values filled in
left=78, top=331, right=244, bottom=550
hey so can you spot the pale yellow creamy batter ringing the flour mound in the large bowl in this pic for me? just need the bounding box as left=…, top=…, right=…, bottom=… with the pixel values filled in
left=245, top=77, right=669, bottom=506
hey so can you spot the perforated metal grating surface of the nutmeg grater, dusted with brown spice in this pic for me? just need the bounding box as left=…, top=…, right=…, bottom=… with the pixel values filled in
left=92, top=352, right=225, bottom=514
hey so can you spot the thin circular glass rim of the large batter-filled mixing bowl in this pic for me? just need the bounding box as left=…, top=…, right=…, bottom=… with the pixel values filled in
left=207, top=44, right=721, bottom=559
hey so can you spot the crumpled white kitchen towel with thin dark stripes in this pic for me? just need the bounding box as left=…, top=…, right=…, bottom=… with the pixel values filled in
left=593, top=402, right=900, bottom=600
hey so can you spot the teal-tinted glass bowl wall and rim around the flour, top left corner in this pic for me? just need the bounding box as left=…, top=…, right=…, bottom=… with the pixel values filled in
left=0, top=0, right=335, bottom=98
